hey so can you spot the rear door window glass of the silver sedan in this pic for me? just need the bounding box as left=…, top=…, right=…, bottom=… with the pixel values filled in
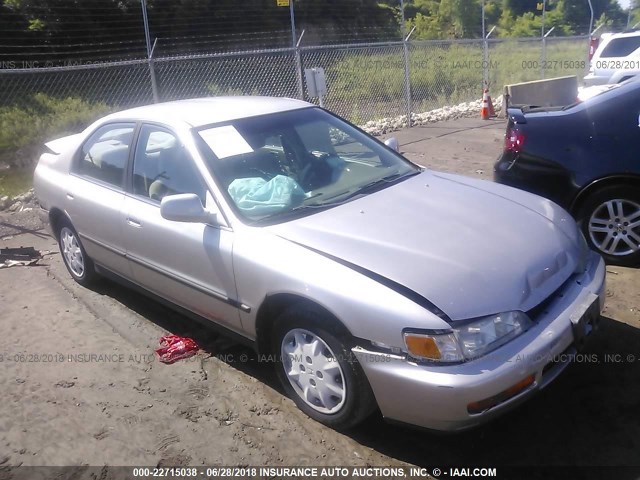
left=75, top=123, right=135, bottom=188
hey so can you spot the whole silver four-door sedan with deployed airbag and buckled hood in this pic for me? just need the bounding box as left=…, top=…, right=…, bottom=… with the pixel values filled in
left=34, top=97, right=605, bottom=431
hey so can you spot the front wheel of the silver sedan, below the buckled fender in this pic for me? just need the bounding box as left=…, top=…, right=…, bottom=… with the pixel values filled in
left=272, top=306, right=377, bottom=430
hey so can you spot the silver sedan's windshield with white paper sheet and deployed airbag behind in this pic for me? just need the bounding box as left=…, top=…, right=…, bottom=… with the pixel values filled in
left=195, top=108, right=420, bottom=223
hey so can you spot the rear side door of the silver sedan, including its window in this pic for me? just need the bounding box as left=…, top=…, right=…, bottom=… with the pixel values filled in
left=65, top=123, right=136, bottom=276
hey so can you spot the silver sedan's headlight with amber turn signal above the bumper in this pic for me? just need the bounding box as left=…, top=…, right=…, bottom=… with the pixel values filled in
left=403, top=311, right=532, bottom=363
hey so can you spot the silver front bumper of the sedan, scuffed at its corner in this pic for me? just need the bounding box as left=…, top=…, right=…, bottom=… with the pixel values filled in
left=353, top=252, right=605, bottom=431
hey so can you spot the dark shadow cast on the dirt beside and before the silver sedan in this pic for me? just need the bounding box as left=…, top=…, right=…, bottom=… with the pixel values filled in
left=85, top=282, right=640, bottom=466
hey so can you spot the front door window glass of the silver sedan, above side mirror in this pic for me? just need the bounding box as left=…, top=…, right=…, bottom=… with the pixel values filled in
left=133, top=125, right=205, bottom=203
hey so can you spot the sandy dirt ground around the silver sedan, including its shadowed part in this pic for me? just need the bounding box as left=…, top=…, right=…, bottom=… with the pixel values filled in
left=0, top=119, right=640, bottom=467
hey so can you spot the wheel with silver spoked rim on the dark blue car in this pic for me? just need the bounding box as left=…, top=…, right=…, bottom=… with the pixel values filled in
left=577, top=185, right=640, bottom=266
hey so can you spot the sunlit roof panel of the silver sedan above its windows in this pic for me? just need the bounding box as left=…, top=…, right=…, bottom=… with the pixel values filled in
left=103, top=96, right=314, bottom=127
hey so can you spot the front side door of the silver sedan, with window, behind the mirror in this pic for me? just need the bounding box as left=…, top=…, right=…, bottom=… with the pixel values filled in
left=124, top=124, right=241, bottom=331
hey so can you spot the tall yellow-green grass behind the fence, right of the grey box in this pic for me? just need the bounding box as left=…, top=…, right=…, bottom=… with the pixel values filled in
left=314, top=39, right=587, bottom=123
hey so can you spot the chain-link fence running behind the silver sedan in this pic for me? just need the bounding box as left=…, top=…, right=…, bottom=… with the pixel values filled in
left=0, top=37, right=588, bottom=124
